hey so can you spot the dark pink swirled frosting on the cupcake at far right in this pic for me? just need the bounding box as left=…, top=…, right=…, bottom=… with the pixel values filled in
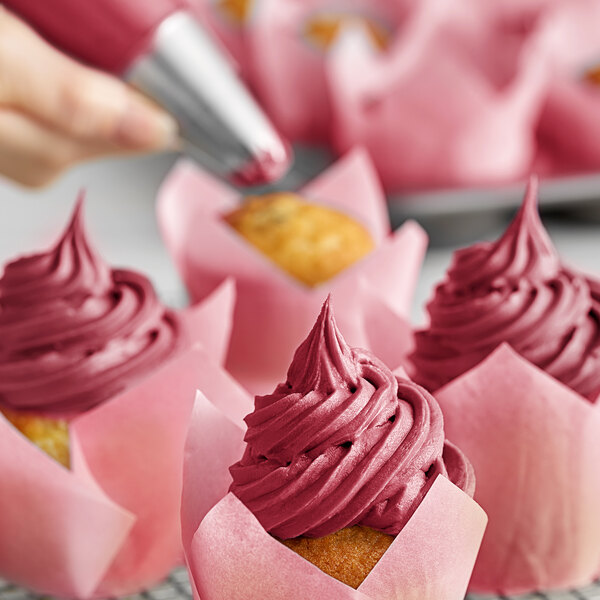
left=412, top=181, right=600, bottom=400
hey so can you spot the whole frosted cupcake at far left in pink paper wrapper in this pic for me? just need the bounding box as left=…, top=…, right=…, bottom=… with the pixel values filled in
left=0, top=201, right=232, bottom=598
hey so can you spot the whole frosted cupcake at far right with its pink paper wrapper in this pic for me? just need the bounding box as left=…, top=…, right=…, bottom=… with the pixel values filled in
left=413, top=180, right=600, bottom=595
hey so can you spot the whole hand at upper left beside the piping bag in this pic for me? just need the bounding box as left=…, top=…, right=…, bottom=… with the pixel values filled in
left=0, top=6, right=177, bottom=187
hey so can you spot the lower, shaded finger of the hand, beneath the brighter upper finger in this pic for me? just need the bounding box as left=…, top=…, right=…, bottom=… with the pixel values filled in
left=0, top=110, right=129, bottom=187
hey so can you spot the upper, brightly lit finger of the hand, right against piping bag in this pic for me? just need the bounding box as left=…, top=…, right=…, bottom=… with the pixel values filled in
left=0, top=8, right=177, bottom=150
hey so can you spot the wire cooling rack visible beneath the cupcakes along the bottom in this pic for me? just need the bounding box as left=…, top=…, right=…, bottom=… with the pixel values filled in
left=0, top=569, right=600, bottom=600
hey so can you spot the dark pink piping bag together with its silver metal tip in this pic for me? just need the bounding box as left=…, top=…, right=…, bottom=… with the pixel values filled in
left=3, top=0, right=291, bottom=185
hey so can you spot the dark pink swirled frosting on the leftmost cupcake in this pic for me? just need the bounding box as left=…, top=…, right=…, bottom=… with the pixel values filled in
left=0, top=202, right=179, bottom=414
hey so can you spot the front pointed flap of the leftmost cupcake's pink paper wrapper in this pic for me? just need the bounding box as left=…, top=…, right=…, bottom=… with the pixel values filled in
left=0, top=415, right=135, bottom=598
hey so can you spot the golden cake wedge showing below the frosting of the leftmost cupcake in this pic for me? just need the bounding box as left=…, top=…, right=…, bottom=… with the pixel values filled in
left=2, top=410, right=70, bottom=468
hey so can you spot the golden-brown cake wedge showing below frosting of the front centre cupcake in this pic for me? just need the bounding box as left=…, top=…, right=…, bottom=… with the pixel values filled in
left=281, top=525, right=394, bottom=589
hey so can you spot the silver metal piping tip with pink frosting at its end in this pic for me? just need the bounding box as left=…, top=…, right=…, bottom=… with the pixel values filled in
left=126, top=12, right=291, bottom=185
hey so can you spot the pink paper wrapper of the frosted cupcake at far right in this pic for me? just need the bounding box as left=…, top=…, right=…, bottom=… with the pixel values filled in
left=436, top=345, right=600, bottom=594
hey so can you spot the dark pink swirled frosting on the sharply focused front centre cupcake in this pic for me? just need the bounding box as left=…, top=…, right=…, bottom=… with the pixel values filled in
left=231, top=300, right=474, bottom=539
